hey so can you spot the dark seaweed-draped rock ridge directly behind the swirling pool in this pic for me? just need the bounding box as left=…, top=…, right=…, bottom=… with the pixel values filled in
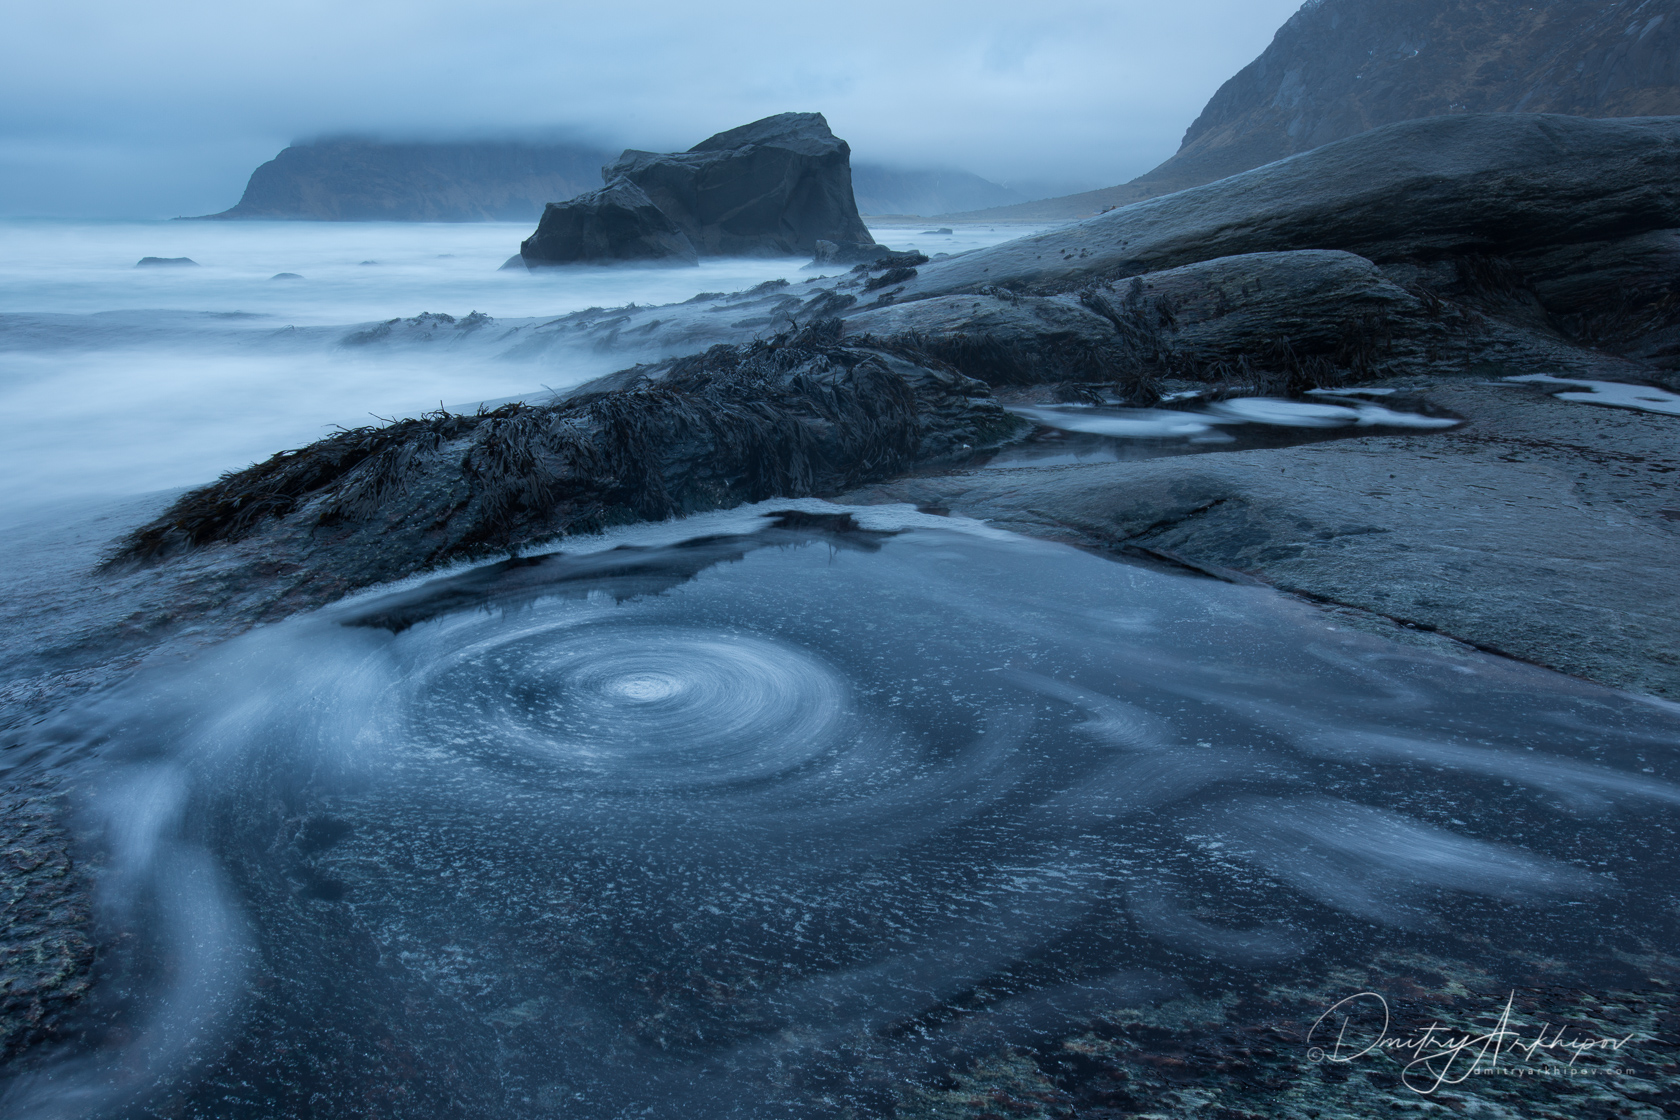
left=118, top=321, right=1018, bottom=610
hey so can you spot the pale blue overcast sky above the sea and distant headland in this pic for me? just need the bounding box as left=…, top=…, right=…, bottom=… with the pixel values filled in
left=0, top=0, right=1300, bottom=217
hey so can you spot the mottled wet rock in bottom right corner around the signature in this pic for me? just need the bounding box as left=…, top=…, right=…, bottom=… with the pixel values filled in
left=904, top=954, right=1680, bottom=1120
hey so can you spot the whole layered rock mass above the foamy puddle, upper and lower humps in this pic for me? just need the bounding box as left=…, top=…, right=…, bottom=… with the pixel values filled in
left=842, top=114, right=1680, bottom=394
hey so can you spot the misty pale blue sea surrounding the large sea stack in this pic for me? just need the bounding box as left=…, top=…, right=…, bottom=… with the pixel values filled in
left=0, top=220, right=1030, bottom=521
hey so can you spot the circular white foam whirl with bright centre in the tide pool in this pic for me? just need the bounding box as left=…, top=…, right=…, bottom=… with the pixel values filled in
left=413, top=623, right=850, bottom=788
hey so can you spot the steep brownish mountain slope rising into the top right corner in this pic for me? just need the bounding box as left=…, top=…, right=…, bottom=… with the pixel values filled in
left=960, top=0, right=1680, bottom=218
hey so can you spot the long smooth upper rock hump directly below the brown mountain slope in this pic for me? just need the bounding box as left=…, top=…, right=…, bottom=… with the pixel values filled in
left=906, top=114, right=1680, bottom=297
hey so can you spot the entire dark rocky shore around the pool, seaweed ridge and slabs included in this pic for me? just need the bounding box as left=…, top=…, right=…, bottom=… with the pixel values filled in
left=0, top=116, right=1680, bottom=1101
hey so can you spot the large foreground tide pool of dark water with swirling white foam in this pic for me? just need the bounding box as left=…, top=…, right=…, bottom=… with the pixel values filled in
left=3, top=502, right=1680, bottom=1117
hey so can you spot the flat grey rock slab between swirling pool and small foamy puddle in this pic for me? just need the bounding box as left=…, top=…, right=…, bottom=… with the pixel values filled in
left=838, top=381, right=1680, bottom=699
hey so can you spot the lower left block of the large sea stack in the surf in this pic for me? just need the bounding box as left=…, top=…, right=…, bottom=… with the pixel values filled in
left=509, top=178, right=701, bottom=267
